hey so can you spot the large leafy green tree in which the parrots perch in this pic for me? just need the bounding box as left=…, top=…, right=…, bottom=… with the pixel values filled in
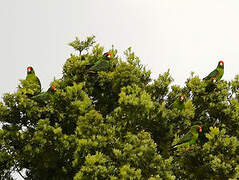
left=0, top=36, right=239, bottom=180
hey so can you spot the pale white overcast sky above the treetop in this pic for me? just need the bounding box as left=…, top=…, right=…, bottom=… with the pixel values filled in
left=0, top=0, right=239, bottom=178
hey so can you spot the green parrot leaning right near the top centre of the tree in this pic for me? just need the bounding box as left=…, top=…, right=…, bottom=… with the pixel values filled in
left=86, top=52, right=111, bottom=73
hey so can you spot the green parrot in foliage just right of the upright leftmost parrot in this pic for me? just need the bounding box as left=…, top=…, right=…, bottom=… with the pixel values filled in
left=32, top=86, right=56, bottom=105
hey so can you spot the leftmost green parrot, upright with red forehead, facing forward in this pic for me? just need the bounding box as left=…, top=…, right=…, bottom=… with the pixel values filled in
left=26, top=66, right=41, bottom=97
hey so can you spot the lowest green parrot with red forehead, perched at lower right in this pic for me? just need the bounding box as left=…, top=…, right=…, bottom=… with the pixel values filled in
left=172, top=125, right=202, bottom=149
